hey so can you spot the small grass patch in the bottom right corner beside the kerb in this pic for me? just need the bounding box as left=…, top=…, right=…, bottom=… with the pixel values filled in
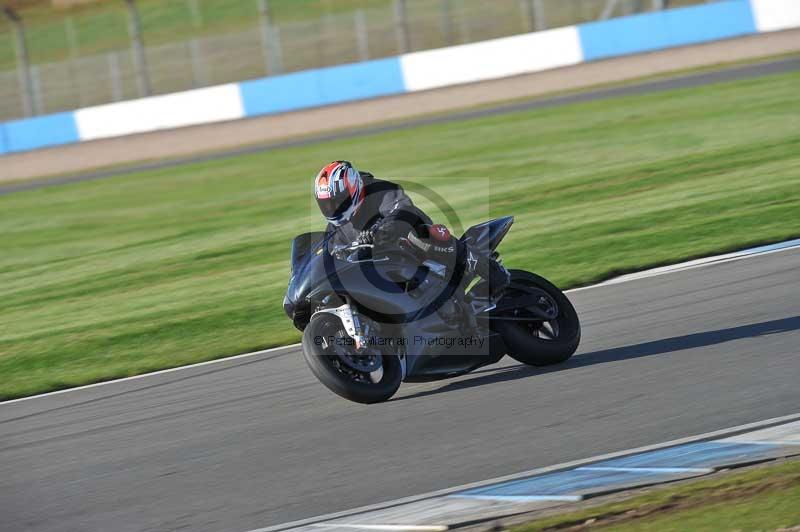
left=512, top=460, right=800, bottom=532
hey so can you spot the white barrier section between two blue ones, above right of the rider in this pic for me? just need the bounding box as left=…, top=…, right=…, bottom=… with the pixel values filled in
left=400, top=26, right=583, bottom=91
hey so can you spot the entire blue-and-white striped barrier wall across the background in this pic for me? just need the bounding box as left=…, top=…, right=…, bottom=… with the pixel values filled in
left=0, top=0, right=800, bottom=155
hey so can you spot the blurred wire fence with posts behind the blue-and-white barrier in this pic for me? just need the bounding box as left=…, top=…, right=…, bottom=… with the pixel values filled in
left=0, top=0, right=708, bottom=120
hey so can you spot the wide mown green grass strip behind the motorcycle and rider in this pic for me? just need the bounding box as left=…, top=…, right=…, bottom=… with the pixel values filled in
left=0, top=69, right=800, bottom=398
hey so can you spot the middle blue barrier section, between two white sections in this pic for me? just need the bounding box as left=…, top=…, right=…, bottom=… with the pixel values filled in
left=239, top=57, right=406, bottom=116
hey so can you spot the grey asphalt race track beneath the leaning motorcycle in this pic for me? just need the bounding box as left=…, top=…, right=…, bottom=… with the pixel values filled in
left=0, top=250, right=800, bottom=532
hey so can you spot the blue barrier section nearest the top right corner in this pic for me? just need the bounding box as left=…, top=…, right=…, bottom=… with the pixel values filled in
left=578, top=0, right=756, bottom=61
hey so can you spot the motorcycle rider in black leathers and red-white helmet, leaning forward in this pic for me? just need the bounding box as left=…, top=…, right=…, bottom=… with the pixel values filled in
left=314, top=161, right=510, bottom=298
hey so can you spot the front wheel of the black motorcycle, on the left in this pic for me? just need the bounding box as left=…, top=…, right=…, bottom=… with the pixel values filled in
left=302, top=313, right=403, bottom=404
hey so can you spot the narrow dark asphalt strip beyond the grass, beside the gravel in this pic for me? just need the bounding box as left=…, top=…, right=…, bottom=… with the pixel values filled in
left=0, top=57, right=800, bottom=196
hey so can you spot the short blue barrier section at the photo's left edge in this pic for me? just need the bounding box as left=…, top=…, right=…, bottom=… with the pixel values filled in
left=3, top=112, right=80, bottom=152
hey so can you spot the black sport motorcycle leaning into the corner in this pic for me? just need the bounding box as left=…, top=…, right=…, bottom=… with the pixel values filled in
left=283, top=217, right=581, bottom=403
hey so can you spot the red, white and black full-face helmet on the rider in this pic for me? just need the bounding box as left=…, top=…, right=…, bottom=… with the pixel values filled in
left=314, top=161, right=365, bottom=225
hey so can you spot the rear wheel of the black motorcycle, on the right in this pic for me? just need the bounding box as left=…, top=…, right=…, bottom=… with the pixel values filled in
left=493, top=270, right=581, bottom=366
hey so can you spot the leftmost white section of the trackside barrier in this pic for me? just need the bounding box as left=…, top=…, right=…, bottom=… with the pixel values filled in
left=75, top=83, right=244, bottom=140
